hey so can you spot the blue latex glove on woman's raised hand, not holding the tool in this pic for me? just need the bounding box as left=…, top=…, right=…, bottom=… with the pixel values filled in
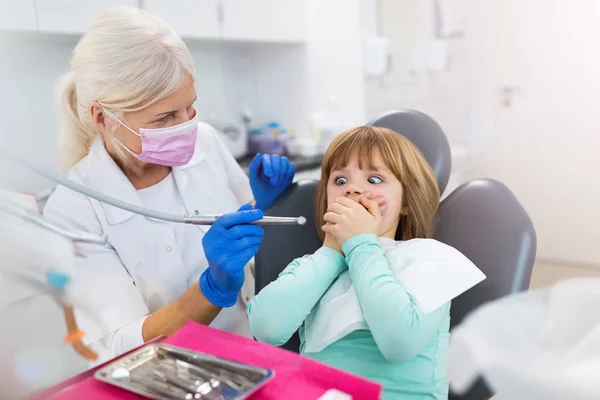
left=250, top=153, right=296, bottom=211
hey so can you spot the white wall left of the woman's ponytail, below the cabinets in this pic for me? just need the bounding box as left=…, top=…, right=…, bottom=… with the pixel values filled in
left=0, top=33, right=76, bottom=190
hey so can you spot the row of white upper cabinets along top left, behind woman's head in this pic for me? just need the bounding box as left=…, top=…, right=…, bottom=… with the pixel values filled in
left=5, top=0, right=307, bottom=43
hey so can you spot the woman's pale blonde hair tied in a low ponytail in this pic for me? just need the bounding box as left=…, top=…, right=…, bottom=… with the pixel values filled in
left=58, top=6, right=195, bottom=169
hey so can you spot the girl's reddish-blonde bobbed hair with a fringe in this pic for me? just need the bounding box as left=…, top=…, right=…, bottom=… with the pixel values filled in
left=315, top=126, right=440, bottom=240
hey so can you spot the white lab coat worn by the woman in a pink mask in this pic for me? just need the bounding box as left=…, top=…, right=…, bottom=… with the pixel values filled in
left=44, top=123, right=254, bottom=359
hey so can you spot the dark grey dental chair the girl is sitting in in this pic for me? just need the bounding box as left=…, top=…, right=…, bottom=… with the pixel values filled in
left=255, top=110, right=537, bottom=400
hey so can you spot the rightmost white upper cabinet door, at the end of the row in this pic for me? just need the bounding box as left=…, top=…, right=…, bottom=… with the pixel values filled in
left=221, top=0, right=306, bottom=43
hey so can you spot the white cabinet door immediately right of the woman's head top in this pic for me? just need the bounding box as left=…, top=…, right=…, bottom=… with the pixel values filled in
left=142, top=0, right=220, bottom=39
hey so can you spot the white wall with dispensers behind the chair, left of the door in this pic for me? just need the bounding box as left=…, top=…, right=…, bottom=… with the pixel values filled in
left=361, top=0, right=495, bottom=181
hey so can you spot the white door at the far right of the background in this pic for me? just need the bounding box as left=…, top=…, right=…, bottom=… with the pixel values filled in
left=490, top=0, right=600, bottom=265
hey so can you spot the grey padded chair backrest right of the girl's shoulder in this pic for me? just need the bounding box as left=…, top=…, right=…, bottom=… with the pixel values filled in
left=435, top=179, right=537, bottom=400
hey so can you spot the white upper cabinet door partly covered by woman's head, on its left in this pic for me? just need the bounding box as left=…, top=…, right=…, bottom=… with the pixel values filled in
left=35, top=0, right=138, bottom=34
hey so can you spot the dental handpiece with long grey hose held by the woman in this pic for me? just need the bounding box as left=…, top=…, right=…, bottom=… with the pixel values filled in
left=0, top=150, right=306, bottom=225
